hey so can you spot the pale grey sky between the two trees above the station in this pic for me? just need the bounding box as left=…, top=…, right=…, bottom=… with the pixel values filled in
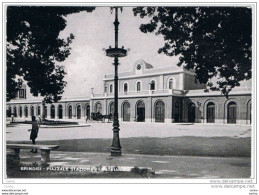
left=57, top=7, right=181, bottom=97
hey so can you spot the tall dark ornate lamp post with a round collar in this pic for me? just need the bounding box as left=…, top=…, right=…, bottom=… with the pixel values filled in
left=106, top=7, right=127, bottom=156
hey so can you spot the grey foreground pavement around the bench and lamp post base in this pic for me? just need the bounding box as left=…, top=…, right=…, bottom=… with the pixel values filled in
left=11, top=151, right=251, bottom=179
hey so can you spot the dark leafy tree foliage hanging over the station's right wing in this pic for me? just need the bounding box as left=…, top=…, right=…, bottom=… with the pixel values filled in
left=133, top=7, right=252, bottom=95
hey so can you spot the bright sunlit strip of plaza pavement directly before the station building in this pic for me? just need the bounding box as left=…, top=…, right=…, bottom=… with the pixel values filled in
left=6, top=122, right=251, bottom=141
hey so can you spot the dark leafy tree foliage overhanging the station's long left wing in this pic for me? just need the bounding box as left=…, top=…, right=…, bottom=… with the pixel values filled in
left=6, top=6, right=94, bottom=102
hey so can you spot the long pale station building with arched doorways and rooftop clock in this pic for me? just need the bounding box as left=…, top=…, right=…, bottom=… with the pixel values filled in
left=7, top=60, right=251, bottom=124
